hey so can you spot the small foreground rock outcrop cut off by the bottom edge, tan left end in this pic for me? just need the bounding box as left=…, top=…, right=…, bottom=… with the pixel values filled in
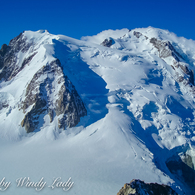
left=117, top=180, right=178, bottom=195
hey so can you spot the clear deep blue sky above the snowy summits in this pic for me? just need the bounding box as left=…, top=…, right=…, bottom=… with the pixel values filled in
left=0, top=0, right=195, bottom=45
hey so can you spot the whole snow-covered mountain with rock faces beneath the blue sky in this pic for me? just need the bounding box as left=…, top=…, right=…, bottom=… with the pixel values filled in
left=0, top=27, right=195, bottom=195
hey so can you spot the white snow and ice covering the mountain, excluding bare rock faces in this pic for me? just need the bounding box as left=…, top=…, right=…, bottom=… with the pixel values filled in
left=0, top=27, right=195, bottom=195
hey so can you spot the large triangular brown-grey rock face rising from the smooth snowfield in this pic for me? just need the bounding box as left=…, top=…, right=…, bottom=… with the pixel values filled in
left=20, top=59, right=87, bottom=132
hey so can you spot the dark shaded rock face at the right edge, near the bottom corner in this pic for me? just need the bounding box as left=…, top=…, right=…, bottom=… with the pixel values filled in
left=166, top=153, right=195, bottom=193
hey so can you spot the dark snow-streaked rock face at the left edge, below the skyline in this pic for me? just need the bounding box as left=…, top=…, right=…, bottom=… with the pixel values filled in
left=0, top=33, right=36, bottom=81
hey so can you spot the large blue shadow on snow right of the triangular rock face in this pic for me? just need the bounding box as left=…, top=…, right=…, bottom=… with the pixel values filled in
left=53, top=40, right=108, bottom=127
